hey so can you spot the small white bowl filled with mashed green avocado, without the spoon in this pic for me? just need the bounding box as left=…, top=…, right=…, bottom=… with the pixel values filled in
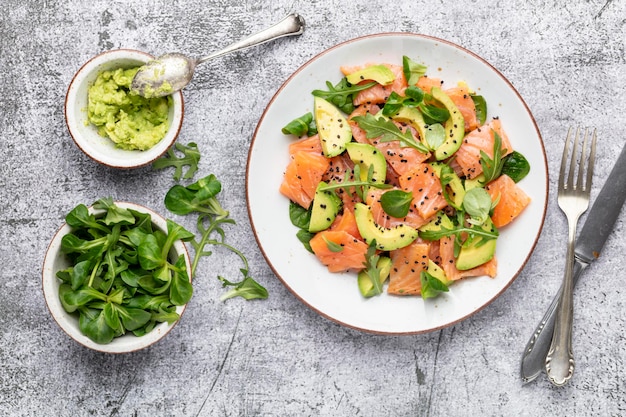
left=65, top=49, right=184, bottom=169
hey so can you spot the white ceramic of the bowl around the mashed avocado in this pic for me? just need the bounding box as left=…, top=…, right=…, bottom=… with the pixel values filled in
left=65, top=49, right=185, bottom=168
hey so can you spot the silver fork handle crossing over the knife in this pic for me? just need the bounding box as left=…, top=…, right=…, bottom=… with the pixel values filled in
left=546, top=218, right=578, bottom=386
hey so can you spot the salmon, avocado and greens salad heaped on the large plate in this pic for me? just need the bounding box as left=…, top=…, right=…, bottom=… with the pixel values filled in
left=279, top=56, right=531, bottom=299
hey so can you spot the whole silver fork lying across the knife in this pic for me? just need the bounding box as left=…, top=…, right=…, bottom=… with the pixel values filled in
left=546, top=128, right=596, bottom=386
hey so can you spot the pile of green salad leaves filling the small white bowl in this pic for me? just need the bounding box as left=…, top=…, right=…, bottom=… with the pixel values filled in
left=56, top=198, right=193, bottom=344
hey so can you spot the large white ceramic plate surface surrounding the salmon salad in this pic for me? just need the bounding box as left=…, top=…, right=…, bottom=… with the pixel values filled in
left=246, top=33, right=548, bottom=334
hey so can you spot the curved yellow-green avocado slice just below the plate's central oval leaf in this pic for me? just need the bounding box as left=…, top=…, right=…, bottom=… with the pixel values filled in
left=354, top=203, right=417, bottom=251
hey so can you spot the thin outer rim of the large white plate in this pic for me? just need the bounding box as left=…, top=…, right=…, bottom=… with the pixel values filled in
left=245, top=32, right=550, bottom=336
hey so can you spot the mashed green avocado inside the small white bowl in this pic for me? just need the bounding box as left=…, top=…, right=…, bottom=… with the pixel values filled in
left=87, top=67, right=172, bottom=151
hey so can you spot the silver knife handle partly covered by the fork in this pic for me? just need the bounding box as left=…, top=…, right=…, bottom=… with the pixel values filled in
left=521, top=259, right=587, bottom=383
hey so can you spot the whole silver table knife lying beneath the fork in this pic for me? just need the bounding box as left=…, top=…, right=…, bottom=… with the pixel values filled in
left=520, top=137, right=626, bottom=383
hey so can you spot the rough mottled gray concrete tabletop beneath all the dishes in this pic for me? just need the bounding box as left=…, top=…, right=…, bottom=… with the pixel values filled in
left=0, top=0, right=626, bottom=417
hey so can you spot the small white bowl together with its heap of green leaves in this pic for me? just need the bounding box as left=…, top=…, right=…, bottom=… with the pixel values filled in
left=42, top=198, right=193, bottom=353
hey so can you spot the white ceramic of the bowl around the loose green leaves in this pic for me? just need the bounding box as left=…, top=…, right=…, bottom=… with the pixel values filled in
left=42, top=201, right=191, bottom=353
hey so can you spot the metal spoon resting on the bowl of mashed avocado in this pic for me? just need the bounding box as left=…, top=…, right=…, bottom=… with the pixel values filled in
left=130, top=14, right=304, bottom=97
